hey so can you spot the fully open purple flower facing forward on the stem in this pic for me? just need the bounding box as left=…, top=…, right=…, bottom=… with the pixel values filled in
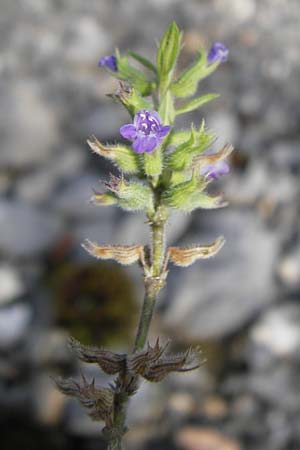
left=120, top=109, right=171, bottom=153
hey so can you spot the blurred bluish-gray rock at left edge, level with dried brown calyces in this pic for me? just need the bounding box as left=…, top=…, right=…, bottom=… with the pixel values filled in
left=0, top=200, right=62, bottom=257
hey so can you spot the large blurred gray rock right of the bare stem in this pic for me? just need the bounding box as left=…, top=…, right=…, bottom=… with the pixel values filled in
left=163, top=209, right=278, bottom=340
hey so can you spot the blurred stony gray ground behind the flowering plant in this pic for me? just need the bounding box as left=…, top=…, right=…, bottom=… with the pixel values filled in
left=0, top=0, right=300, bottom=450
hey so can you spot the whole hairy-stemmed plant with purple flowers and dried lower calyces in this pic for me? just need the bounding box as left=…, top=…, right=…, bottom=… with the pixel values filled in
left=57, top=22, right=232, bottom=450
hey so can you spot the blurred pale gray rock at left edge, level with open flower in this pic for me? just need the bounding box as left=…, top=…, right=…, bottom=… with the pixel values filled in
left=0, top=80, right=59, bottom=169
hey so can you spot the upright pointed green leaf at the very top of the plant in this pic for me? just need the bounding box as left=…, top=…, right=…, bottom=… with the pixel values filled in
left=157, top=22, right=181, bottom=92
